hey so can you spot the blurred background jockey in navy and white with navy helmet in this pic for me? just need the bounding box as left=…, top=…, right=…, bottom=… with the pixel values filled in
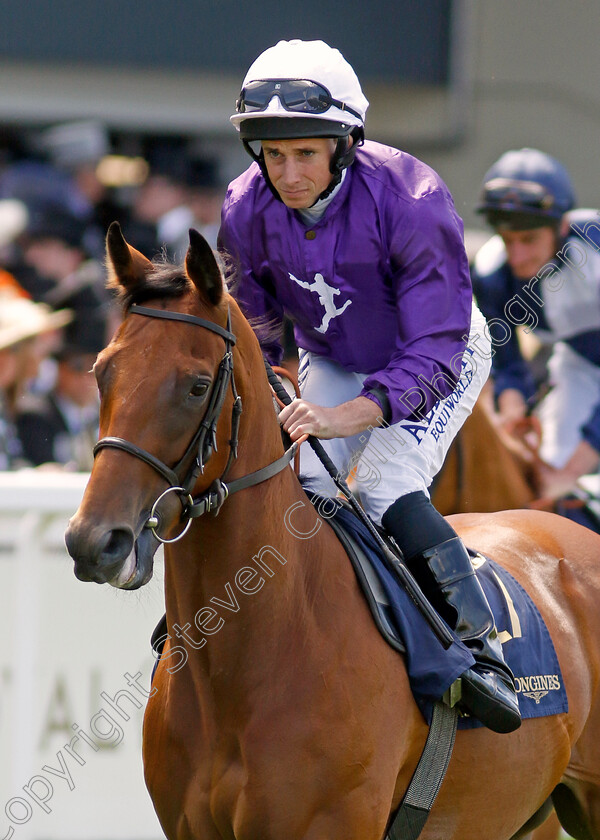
left=473, top=149, right=600, bottom=499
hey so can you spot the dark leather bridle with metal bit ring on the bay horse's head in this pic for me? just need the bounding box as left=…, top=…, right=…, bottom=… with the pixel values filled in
left=94, top=303, right=296, bottom=543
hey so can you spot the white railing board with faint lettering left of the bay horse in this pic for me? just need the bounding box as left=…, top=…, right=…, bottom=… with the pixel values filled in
left=0, top=471, right=164, bottom=840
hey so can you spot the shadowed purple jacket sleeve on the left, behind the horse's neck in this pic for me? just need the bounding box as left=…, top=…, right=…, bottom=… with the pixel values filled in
left=217, top=194, right=283, bottom=365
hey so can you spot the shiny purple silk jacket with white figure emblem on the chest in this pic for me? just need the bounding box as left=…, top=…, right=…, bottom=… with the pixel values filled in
left=219, top=141, right=472, bottom=423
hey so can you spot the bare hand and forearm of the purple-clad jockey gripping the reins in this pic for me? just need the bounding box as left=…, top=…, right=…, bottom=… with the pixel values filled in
left=279, top=397, right=381, bottom=440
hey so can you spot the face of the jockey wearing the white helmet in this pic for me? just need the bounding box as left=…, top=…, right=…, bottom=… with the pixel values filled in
left=262, top=137, right=335, bottom=210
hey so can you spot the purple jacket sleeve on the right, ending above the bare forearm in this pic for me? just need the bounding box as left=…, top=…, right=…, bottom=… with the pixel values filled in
left=362, top=188, right=472, bottom=423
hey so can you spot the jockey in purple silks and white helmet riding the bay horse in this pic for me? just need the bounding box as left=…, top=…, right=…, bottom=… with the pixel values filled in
left=219, top=40, right=520, bottom=732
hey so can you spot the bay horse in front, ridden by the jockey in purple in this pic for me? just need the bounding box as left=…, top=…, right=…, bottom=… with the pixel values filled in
left=66, top=225, right=600, bottom=840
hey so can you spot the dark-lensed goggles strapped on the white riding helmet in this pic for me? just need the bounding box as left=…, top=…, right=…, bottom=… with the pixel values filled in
left=235, top=79, right=362, bottom=121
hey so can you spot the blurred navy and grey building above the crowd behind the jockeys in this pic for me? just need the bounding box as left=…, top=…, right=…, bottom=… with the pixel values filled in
left=0, top=0, right=600, bottom=228
